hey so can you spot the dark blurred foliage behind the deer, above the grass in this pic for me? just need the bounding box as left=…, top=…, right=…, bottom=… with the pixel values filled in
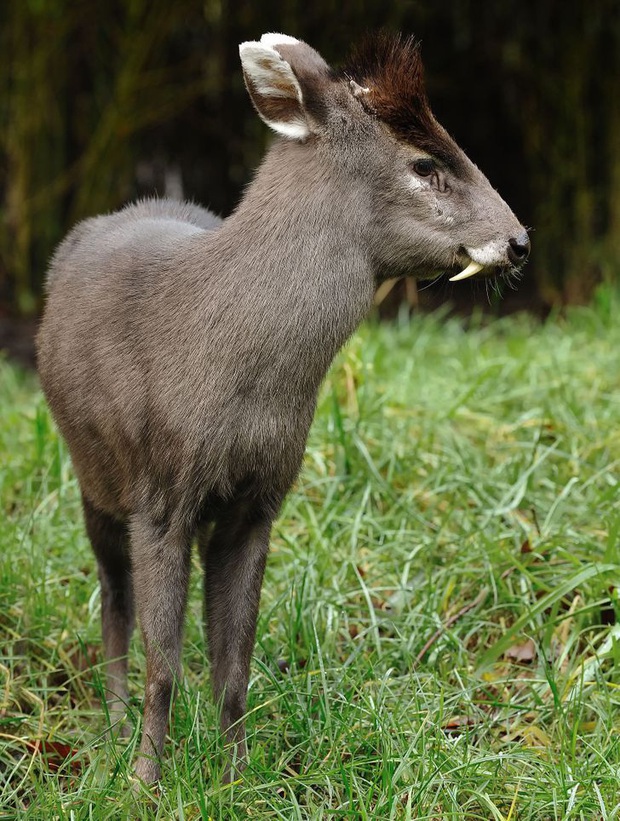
left=0, top=0, right=620, bottom=317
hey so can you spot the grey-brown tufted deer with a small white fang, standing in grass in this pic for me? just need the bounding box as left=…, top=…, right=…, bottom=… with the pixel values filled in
left=38, top=34, right=529, bottom=781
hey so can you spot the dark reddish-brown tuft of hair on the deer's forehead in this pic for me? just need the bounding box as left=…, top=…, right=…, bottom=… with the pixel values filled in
left=340, top=32, right=460, bottom=168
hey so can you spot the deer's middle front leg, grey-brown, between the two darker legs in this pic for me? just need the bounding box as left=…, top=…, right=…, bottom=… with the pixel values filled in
left=131, top=517, right=190, bottom=783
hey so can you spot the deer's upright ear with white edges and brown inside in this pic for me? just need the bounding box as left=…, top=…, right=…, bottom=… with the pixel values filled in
left=239, top=34, right=310, bottom=140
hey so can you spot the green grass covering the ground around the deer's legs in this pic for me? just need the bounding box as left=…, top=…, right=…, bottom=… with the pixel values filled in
left=0, top=294, right=620, bottom=821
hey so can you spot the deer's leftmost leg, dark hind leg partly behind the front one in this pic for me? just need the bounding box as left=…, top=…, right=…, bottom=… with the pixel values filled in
left=82, top=497, right=134, bottom=735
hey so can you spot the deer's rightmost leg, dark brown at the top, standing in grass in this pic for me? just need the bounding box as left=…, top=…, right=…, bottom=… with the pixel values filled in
left=199, top=506, right=271, bottom=777
